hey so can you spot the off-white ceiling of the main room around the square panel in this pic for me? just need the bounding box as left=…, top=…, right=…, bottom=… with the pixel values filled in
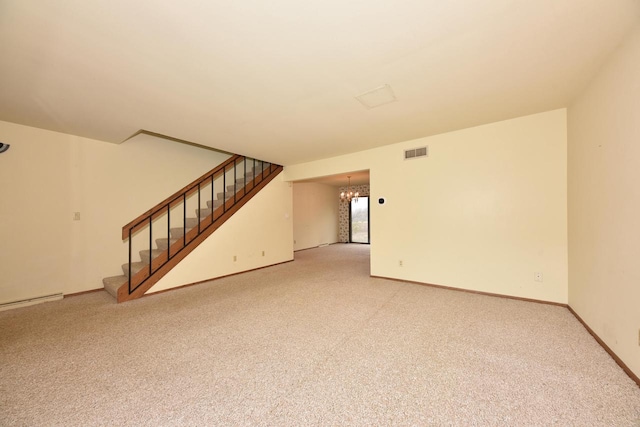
left=0, top=0, right=640, bottom=165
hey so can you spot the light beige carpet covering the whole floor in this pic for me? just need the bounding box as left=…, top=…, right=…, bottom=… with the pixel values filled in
left=0, top=245, right=640, bottom=426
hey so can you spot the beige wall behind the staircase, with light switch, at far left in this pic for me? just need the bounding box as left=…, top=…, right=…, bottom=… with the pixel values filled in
left=0, top=122, right=228, bottom=303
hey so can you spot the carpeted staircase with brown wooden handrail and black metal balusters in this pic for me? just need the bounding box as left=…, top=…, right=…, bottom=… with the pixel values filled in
left=102, top=155, right=282, bottom=302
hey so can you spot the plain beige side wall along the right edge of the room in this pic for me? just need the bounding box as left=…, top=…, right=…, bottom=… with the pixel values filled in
left=568, top=28, right=640, bottom=376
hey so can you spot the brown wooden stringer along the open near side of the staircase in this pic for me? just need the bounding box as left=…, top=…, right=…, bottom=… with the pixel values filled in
left=116, top=166, right=283, bottom=303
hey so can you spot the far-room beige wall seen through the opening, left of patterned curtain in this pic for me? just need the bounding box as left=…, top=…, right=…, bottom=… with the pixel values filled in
left=293, top=183, right=339, bottom=250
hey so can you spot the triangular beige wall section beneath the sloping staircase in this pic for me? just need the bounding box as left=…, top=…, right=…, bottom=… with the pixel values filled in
left=149, top=174, right=293, bottom=293
